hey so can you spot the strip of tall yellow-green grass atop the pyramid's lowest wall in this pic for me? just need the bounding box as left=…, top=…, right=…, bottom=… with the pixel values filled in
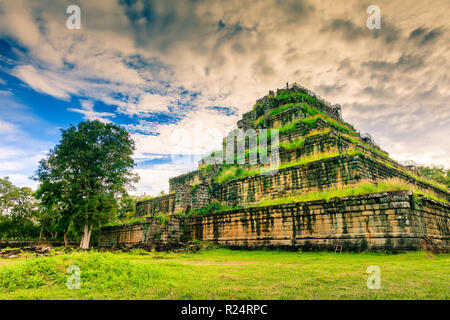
left=256, top=178, right=448, bottom=207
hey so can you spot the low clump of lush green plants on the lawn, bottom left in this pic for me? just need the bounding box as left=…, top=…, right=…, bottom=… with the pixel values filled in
left=0, top=252, right=160, bottom=292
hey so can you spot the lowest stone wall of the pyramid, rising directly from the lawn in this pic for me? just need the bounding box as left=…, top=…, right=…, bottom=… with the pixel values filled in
left=187, top=191, right=450, bottom=252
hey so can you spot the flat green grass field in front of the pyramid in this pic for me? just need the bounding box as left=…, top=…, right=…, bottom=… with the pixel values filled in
left=0, top=249, right=450, bottom=299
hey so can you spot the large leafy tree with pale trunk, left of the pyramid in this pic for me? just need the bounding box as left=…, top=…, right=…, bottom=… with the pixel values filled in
left=35, top=121, right=138, bottom=249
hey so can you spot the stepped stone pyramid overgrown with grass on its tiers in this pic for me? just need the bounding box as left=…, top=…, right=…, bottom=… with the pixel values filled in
left=99, top=84, right=450, bottom=251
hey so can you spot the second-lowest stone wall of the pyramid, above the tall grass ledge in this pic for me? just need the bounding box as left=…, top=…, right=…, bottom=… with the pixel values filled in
left=213, top=155, right=450, bottom=206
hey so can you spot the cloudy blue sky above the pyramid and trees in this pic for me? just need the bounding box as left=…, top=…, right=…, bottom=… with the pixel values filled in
left=0, top=0, right=450, bottom=194
